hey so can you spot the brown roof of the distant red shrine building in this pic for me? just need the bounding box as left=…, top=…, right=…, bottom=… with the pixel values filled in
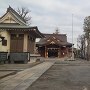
left=37, top=34, right=72, bottom=46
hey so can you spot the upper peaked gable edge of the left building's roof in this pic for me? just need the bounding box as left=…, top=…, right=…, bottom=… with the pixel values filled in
left=0, top=6, right=26, bottom=25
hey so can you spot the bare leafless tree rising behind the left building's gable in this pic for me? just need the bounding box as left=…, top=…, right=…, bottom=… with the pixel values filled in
left=17, top=7, right=31, bottom=25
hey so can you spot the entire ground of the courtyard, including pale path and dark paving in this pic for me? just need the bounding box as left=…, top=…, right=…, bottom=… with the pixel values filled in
left=0, top=59, right=90, bottom=90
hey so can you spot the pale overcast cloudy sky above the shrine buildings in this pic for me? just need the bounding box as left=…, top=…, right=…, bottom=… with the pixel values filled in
left=0, top=0, right=90, bottom=47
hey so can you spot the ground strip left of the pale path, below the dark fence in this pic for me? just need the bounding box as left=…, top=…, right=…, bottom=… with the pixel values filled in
left=0, top=60, right=41, bottom=79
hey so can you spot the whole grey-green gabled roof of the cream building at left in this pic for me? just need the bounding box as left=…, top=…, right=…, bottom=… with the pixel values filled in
left=0, top=6, right=44, bottom=38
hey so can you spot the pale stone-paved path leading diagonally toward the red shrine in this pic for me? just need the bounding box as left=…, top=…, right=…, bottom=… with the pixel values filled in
left=0, top=61, right=55, bottom=90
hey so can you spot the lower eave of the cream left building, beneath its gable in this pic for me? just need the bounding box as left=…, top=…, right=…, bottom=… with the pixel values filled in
left=0, top=25, right=44, bottom=38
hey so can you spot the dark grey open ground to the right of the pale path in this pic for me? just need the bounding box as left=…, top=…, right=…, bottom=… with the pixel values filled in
left=27, top=61, right=90, bottom=90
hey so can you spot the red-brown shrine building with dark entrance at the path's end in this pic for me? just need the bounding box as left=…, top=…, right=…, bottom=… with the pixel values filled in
left=36, top=34, right=72, bottom=58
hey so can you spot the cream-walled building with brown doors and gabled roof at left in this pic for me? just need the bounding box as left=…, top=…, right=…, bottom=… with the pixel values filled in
left=0, top=6, right=43, bottom=53
